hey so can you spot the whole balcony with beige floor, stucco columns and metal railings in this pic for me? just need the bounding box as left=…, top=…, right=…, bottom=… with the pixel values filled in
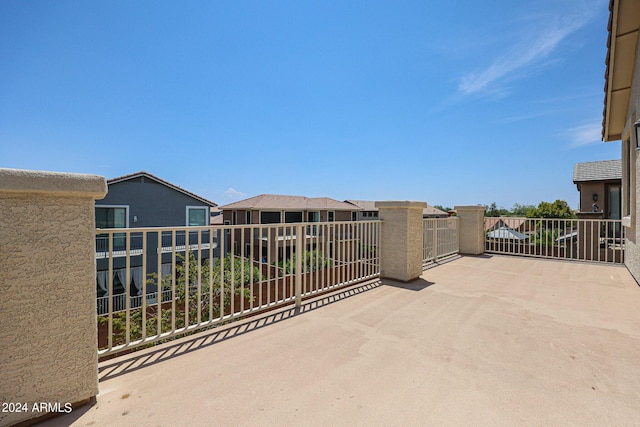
left=0, top=171, right=640, bottom=425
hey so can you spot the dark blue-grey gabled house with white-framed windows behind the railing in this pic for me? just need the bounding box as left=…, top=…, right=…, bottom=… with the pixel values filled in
left=95, top=171, right=218, bottom=314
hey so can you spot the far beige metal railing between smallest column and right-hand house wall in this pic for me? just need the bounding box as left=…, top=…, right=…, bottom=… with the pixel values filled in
left=485, top=217, right=625, bottom=264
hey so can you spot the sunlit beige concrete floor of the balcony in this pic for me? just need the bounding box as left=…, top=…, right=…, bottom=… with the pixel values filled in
left=44, top=256, right=640, bottom=426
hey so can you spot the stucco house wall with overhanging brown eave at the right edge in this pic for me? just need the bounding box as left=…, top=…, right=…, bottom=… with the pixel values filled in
left=602, top=0, right=640, bottom=282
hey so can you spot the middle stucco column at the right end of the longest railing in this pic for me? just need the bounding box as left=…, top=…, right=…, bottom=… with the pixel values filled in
left=376, top=201, right=427, bottom=282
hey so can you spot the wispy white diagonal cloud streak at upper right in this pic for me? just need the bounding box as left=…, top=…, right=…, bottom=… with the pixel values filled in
left=458, top=5, right=593, bottom=95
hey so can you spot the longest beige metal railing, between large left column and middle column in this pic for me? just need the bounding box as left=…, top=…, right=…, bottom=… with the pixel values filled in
left=96, top=221, right=380, bottom=355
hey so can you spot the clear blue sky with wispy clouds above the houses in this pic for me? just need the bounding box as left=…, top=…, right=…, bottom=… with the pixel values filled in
left=0, top=0, right=620, bottom=208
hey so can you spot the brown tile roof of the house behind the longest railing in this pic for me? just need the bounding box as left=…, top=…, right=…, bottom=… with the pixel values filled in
left=220, top=194, right=360, bottom=211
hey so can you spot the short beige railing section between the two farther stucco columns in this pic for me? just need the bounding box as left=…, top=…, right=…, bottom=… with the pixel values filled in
left=422, top=217, right=460, bottom=264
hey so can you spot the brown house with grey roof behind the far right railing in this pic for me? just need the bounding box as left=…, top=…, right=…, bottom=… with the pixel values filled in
left=573, top=159, right=622, bottom=219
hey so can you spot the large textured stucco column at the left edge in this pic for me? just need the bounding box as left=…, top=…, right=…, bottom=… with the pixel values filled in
left=0, top=169, right=107, bottom=425
